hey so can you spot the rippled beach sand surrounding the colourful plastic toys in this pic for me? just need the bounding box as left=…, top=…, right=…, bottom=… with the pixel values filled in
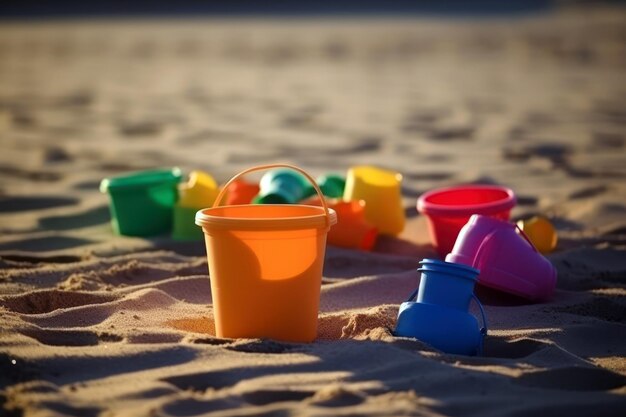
left=0, top=4, right=626, bottom=417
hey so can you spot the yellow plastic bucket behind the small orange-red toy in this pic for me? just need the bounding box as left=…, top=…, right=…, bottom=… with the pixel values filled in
left=343, top=166, right=405, bottom=235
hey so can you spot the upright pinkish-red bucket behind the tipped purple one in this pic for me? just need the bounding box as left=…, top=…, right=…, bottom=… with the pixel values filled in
left=417, top=185, right=516, bottom=257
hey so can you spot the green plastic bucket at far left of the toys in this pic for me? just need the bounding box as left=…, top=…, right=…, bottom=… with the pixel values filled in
left=100, top=168, right=181, bottom=236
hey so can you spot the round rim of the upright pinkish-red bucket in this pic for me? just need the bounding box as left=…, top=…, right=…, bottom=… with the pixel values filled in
left=417, top=184, right=517, bottom=217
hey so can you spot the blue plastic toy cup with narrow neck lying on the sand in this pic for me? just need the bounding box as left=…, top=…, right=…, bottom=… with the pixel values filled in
left=395, top=259, right=487, bottom=355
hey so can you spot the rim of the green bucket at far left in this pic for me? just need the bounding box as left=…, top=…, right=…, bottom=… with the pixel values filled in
left=100, top=167, right=182, bottom=193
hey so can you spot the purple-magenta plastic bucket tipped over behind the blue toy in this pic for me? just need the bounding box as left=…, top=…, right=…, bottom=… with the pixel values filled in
left=446, top=215, right=557, bottom=301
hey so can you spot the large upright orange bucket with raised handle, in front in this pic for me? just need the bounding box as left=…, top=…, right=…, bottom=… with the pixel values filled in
left=196, top=164, right=337, bottom=342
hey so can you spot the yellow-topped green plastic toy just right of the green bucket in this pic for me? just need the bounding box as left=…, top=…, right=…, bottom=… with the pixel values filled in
left=172, top=171, right=218, bottom=240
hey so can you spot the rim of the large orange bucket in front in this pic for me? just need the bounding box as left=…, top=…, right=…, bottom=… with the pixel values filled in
left=195, top=204, right=337, bottom=231
